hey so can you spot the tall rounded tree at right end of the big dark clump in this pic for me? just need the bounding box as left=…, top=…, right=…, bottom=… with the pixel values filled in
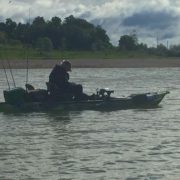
left=63, top=15, right=112, bottom=50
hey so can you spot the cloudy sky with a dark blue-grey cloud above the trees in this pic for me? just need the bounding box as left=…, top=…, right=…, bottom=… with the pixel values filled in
left=0, top=0, right=180, bottom=47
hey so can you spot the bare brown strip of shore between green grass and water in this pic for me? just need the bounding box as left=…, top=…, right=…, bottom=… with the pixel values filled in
left=0, top=58, right=180, bottom=69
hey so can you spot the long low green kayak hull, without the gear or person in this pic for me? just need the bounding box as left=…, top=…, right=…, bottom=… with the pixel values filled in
left=0, top=91, right=169, bottom=112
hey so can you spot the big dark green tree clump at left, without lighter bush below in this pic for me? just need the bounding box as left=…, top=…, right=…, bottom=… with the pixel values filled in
left=0, top=15, right=112, bottom=50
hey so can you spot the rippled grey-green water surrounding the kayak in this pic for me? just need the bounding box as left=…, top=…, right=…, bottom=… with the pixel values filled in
left=0, top=68, right=180, bottom=180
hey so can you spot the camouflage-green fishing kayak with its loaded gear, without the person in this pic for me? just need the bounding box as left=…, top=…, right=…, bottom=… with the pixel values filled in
left=0, top=87, right=169, bottom=112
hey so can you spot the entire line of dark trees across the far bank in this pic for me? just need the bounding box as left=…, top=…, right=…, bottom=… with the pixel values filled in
left=0, top=15, right=180, bottom=56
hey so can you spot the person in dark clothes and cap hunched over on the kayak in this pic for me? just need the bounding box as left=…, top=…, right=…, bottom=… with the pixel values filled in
left=48, top=60, right=88, bottom=100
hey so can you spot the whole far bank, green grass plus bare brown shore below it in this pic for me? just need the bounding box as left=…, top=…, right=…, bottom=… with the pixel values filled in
left=0, top=46, right=180, bottom=69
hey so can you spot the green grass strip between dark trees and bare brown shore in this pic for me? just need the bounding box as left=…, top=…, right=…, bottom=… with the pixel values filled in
left=0, top=46, right=160, bottom=60
